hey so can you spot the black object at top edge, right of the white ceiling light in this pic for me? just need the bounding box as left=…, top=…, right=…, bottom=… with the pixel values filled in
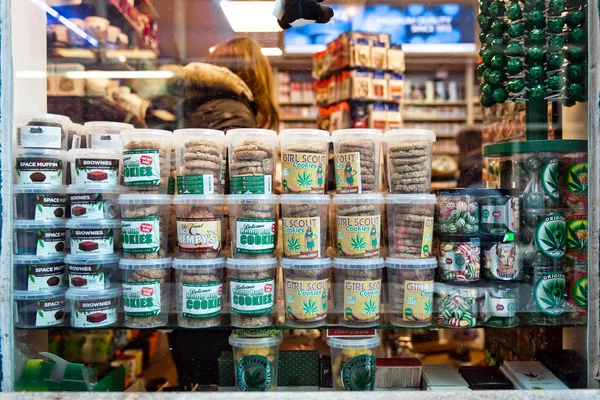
left=273, top=0, right=333, bottom=29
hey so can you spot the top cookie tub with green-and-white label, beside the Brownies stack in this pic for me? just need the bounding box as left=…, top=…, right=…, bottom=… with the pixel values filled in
left=121, top=129, right=172, bottom=194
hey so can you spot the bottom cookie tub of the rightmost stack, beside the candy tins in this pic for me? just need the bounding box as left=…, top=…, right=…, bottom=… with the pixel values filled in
left=385, top=257, right=437, bottom=328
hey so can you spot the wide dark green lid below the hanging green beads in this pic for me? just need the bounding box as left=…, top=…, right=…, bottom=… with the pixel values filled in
left=483, top=140, right=587, bottom=157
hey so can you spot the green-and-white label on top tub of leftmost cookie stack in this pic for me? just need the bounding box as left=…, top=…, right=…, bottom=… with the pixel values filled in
left=123, top=150, right=160, bottom=186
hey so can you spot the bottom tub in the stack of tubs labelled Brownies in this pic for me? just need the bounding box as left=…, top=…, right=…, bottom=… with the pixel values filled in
left=65, top=286, right=121, bottom=328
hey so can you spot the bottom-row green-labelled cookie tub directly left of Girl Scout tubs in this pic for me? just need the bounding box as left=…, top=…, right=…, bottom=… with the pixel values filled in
left=225, top=258, right=277, bottom=328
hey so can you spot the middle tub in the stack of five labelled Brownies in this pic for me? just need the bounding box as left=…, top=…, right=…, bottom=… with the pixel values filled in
left=66, top=219, right=121, bottom=254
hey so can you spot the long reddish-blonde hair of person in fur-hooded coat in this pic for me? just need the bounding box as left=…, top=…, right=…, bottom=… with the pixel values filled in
left=208, top=38, right=279, bottom=130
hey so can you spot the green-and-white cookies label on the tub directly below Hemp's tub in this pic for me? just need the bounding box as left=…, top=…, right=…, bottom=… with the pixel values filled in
left=181, top=282, right=223, bottom=318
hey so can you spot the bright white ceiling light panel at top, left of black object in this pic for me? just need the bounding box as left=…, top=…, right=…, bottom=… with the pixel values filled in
left=220, top=0, right=282, bottom=32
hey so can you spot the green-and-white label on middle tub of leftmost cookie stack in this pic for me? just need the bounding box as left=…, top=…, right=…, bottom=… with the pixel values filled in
left=121, top=216, right=160, bottom=253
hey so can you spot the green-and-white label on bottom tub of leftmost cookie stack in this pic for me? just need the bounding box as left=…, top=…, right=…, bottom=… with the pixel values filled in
left=123, top=281, right=161, bottom=317
